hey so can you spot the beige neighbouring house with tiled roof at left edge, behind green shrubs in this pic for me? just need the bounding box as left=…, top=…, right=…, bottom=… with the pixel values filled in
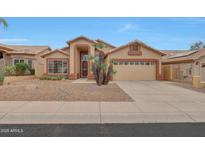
left=0, top=44, right=51, bottom=71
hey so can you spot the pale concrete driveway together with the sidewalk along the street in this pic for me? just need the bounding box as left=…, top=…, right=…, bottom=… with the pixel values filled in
left=0, top=81, right=205, bottom=124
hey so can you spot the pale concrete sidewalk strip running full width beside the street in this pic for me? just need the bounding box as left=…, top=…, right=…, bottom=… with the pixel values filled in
left=0, top=102, right=205, bottom=124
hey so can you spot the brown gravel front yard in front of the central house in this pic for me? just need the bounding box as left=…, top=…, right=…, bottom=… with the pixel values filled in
left=0, top=79, right=133, bottom=101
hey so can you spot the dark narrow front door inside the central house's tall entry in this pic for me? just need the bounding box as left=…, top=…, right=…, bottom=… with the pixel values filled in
left=80, top=52, right=88, bottom=78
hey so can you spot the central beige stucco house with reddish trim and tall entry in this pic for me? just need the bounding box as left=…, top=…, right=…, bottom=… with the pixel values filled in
left=40, top=36, right=165, bottom=80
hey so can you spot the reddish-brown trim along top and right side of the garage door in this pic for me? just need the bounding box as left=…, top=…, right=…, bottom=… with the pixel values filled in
left=112, top=58, right=161, bottom=80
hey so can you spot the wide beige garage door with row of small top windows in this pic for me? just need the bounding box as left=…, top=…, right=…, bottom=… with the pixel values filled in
left=113, top=62, right=156, bottom=80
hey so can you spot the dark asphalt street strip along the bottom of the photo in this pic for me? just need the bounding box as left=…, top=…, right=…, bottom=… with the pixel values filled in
left=0, top=123, right=205, bottom=137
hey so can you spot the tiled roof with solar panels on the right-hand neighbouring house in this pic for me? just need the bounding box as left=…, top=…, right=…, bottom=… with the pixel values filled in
left=162, top=49, right=205, bottom=64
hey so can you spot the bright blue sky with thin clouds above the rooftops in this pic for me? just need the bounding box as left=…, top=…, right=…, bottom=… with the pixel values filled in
left=0, top=17, right=205, bottom=50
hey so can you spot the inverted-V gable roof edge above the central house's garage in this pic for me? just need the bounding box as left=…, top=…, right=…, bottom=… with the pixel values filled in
left=108, top=40, right=166, bottom=56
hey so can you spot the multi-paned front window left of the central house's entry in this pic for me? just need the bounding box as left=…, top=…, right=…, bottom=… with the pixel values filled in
left=48, top=60, right=68, bottom=74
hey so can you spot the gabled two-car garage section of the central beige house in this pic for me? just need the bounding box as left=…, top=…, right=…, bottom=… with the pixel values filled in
left=109, top=41, right=164, bottom=80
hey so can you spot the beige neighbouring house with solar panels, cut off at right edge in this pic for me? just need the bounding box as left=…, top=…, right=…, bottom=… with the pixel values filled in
left=162, top=49, right=205, bottom=87
